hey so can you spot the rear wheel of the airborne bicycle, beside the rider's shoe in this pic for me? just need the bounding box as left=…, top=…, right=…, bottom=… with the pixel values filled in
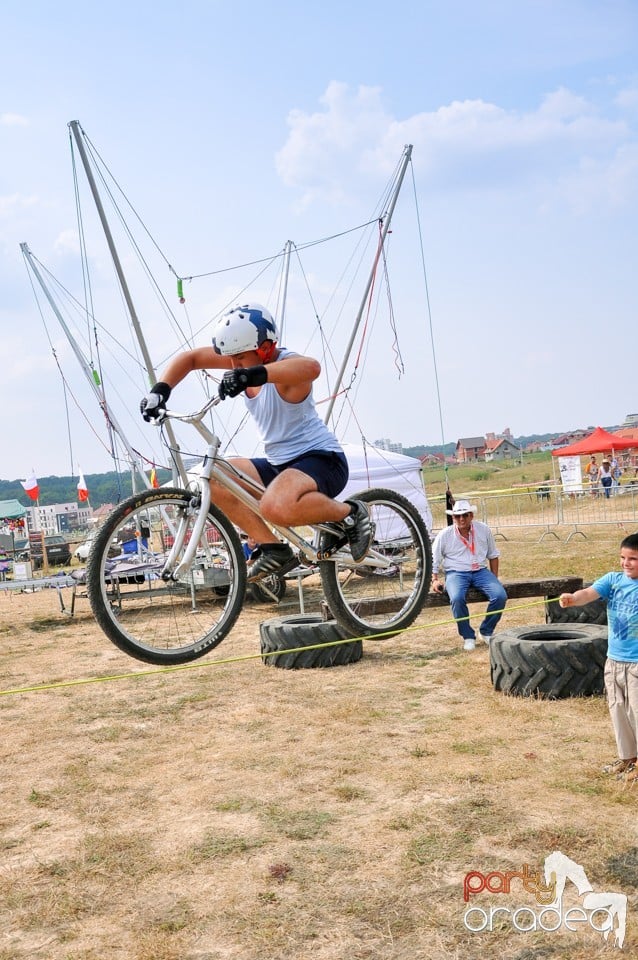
left=319, top=489, right=432, bottom=637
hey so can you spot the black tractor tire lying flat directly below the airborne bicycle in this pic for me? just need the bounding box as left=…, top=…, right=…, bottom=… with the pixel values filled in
left=259, top=613, right=363, bottom=670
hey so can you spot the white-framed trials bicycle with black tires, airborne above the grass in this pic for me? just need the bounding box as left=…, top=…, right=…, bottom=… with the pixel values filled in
left=86, top=397, right=432, bottom=664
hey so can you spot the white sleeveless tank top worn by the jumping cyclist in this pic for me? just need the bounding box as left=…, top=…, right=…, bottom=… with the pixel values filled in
left=244, top=347, right=343, bottom=466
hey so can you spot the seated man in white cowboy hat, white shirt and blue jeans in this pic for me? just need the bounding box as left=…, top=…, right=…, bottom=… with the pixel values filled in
left=432, top=500, right=507, bottom=650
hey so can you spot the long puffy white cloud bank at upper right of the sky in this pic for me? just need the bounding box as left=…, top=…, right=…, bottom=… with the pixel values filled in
left=276, top=82, right=635, bottom=204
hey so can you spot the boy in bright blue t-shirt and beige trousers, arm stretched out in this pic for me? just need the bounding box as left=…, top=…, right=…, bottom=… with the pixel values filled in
left=559, top=533, right=638, bottom=782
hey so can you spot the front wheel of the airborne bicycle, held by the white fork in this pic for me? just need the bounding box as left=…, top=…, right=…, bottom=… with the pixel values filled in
left=86, top=488, right=246, bottom=664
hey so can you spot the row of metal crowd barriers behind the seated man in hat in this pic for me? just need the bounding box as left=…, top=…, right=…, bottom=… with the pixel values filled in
left=430, top=484, right=638, bottom=540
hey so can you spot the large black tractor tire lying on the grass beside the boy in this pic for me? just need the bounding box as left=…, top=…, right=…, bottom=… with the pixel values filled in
left=490, top=624, right=607, bottom=700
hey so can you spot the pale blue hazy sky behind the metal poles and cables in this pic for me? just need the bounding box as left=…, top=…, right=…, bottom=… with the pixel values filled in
left=0, top=0, right=638, bottom=479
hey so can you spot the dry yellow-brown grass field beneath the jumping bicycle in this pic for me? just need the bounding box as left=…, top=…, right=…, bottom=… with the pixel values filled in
left=0, top=528, right=638, bottom=960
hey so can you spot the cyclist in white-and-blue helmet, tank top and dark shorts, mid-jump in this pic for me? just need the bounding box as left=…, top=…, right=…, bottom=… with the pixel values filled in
left=140, top=303, right=372, bottom=581
